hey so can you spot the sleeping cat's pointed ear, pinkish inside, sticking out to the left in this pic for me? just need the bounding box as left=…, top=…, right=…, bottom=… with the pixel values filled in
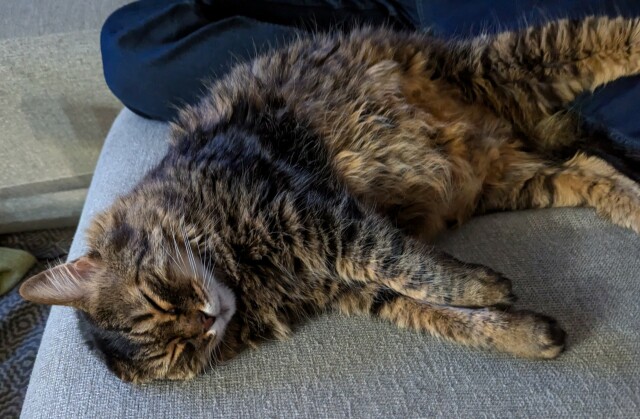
left=20, top=256, right=100, bottom=311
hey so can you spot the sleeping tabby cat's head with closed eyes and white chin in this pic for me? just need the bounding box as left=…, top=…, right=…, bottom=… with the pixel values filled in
left=20, top=205, right=235, bottom=383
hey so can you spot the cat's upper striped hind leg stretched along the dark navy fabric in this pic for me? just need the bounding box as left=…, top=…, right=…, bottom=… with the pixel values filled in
left=441, top=16, right=640, bottom=151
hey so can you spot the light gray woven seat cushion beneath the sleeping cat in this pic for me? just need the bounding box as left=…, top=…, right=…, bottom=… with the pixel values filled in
left=23, top=111, right=640, bottom=419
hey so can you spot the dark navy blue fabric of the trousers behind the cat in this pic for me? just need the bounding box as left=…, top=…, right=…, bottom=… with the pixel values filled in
left=101, top=0, right=640, bottom=151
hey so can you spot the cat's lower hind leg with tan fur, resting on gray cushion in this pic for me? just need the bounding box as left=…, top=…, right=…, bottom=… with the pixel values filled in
left=479, top=153, right=640, bottom=233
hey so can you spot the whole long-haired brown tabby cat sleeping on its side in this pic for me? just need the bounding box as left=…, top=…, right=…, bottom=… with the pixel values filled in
left=20, top=17, right=640, bottom=383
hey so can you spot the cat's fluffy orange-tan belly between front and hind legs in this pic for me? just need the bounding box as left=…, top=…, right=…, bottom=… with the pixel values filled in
left=332, top=81, right=517, bottom=240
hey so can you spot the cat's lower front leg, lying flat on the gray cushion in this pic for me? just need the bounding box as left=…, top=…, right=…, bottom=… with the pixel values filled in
left=334, top=286, right=566, bottom=359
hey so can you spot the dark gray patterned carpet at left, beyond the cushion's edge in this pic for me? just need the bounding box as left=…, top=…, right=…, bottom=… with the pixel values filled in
left=0, top=228, right=75, bottom=418
